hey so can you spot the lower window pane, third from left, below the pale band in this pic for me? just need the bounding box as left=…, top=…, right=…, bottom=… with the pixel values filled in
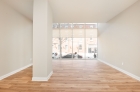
left=73, top=38, right=85, bottom=59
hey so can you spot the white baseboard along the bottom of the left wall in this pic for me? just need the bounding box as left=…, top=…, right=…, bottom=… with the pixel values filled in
left=0, top=64, right=32, bottom=80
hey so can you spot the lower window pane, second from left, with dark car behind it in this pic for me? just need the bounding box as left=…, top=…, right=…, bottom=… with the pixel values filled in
left=61, top=38, right=73, bottom=59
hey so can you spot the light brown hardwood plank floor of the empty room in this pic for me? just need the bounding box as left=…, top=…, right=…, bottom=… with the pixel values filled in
left=0, top=60, right=140, bottom=92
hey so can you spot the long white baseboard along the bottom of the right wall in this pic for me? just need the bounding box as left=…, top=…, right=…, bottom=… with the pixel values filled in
left=97, top=59, right=140, bottom=81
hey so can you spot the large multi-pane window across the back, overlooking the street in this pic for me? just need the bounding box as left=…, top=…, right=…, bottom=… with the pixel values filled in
left=52, top=23, right=97, bottom=59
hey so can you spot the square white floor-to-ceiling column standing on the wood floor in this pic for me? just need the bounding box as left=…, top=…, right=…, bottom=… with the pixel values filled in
left=32, top=0, right=53, bottom=81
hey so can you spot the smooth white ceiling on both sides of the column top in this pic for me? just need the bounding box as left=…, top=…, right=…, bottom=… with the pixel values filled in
left=4, top=0, right=138, bottom=23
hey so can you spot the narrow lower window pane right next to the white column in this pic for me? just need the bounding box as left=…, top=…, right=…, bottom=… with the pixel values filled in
left=52, top=38, right=60, bottom=59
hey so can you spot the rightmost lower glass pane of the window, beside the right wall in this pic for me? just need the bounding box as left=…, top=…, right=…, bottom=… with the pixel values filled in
left=86, top=38, right=97, bottom=59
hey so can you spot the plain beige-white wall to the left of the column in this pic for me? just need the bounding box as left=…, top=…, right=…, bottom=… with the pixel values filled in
left=0, top=0, right=32, bottom=76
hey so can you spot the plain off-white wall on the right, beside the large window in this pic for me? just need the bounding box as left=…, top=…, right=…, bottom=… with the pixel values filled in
left=98, top=1, right=140, bottom=77
